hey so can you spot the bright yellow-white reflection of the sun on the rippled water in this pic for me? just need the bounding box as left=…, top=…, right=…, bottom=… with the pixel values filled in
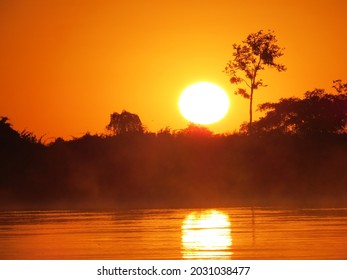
left=182, top=210, right=232, bottom=259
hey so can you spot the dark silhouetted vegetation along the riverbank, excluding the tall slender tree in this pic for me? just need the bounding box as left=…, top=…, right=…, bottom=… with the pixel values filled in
left=0, top=89, right=347, bottom=209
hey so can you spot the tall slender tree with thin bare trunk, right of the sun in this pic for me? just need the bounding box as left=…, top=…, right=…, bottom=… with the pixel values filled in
left=224, top=30, right=286, bottom=134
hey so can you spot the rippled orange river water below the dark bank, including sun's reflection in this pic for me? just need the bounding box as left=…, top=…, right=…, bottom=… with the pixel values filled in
left=0, top=208, right=347, bottom=259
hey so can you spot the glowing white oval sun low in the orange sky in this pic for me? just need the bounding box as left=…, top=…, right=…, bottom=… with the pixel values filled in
left=178, top=82, right=230, bottom=125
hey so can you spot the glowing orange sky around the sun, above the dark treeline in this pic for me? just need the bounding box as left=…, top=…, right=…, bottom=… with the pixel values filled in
left=0, top=0, right=347, bottom=142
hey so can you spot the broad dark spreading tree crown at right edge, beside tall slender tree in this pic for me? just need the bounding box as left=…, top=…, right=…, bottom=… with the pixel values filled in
left=254, top=81, right=347, bottom=135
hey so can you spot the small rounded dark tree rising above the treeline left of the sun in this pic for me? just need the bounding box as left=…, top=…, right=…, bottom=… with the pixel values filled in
left=106, top=110, right=144, bottom=135
